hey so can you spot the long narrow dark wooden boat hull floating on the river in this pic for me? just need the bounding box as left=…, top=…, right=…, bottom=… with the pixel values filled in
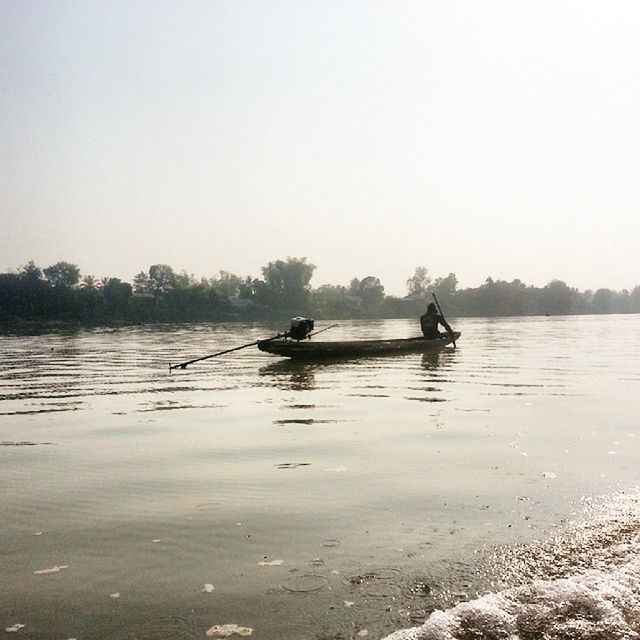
left=258, top=331, right=460, bottom=360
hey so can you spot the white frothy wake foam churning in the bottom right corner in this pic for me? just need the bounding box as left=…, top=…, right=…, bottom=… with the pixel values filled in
left=387, top=494, right=640, bottom=640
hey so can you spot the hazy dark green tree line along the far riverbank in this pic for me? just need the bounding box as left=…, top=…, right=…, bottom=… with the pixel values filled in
left=0, top=258, right=640, bottom=325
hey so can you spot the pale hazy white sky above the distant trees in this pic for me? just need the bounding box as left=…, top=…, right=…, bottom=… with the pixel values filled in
left=0, top=0, right=640, bottom=294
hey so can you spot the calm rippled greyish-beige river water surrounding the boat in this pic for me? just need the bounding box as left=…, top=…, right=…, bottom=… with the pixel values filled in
left=0, top=316, right=640, bottom=640
